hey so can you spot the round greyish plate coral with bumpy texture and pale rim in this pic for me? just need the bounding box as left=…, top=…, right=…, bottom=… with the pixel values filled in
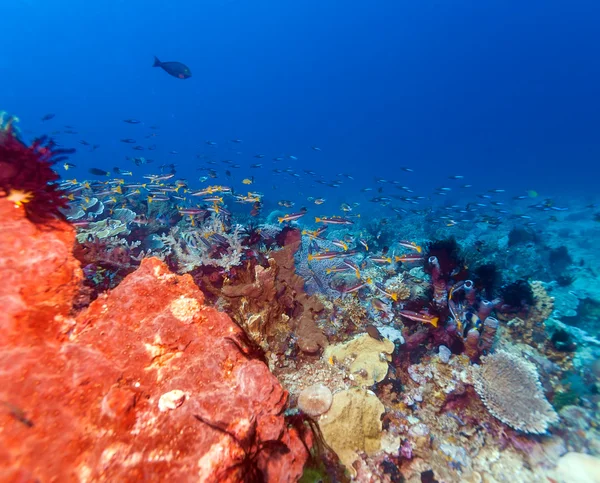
left=474, top=351, right=558, bottom=434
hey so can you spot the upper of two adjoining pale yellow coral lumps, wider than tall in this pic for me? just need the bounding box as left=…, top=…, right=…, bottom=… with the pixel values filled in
left=323, top=334, right=395, bottom=386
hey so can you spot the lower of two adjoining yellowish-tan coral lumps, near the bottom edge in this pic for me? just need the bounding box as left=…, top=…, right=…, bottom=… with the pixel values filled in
left=319, top=388, right=385, bottom=474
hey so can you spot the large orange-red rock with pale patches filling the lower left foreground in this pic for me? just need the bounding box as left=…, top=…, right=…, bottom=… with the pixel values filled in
left=0, top=258, right=308, bottom=482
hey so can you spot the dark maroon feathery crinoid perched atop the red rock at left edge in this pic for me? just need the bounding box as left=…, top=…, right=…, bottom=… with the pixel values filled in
left=0, top=119, right=73, bottom=223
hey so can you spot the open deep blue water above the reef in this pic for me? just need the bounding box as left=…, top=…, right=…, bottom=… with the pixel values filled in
left=0, top=0, right=600, bottom=202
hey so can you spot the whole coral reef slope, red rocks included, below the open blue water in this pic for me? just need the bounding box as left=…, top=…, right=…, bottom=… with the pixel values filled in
left=0, top=118, right=600, bottom=483
